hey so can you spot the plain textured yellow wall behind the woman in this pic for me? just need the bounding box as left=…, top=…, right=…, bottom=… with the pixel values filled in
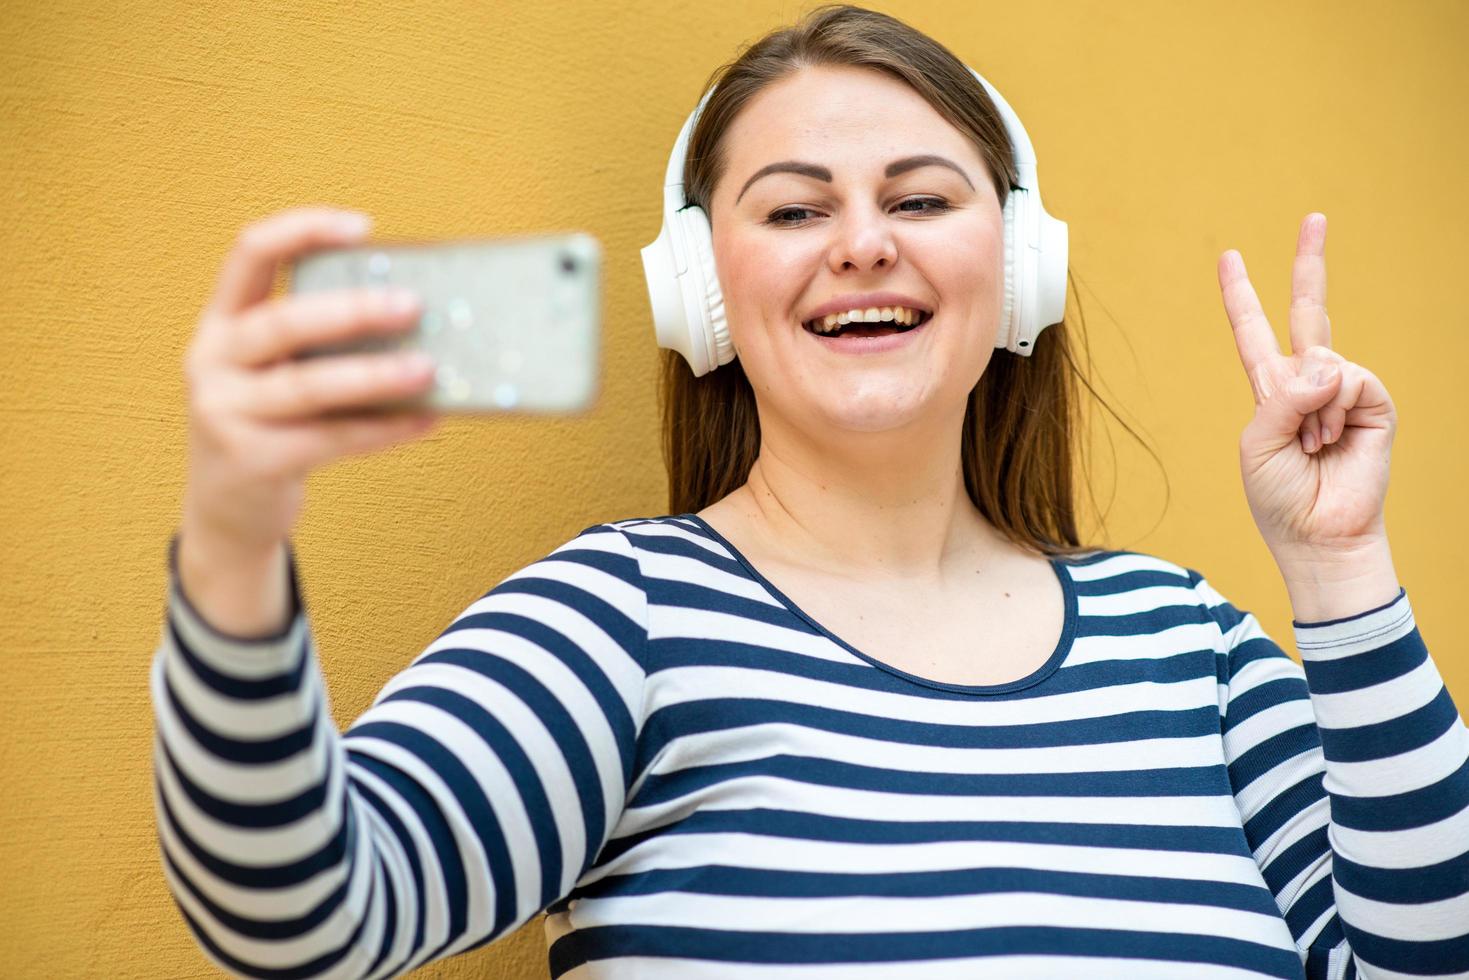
left=0, top=0, right=1469, bottom=979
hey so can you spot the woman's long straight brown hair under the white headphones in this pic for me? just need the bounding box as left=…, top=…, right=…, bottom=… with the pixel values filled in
left=660, top=4, right=1156, bottom=554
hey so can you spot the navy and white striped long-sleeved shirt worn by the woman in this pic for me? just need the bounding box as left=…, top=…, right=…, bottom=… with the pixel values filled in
left=151, top=514, right=1469, bottom=980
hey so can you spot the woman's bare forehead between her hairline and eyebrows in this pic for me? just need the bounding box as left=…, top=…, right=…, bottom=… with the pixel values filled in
left=724, top=65, right=983, bottom=166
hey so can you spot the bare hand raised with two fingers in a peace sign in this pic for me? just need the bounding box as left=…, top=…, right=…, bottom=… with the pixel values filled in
left=1219, top=212, right=1397, bottom=569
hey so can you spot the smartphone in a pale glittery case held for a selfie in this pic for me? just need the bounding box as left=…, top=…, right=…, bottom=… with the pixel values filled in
left=288, top=232, right=602, bottom=414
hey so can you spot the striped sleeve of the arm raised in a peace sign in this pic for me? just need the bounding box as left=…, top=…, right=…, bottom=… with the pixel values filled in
left=1188, top=569, right=1469, bottom=980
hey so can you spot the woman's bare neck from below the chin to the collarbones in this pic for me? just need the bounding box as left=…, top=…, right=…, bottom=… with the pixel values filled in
left=732, top=414, right=1002, bottom=579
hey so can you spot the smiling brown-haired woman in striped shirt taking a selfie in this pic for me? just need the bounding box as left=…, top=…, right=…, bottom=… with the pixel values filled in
left=153, top=7, right=1469, bottom=977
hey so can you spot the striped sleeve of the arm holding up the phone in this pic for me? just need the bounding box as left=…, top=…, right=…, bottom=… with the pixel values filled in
left=150, top=525, right=648, bottom=977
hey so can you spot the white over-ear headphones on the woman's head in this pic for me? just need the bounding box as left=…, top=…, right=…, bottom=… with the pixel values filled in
left=642, top=68, right=1068, bottom=376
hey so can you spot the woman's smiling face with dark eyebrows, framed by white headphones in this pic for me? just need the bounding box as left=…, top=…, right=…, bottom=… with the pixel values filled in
left=710, top=66, right=1003, bottom=436
